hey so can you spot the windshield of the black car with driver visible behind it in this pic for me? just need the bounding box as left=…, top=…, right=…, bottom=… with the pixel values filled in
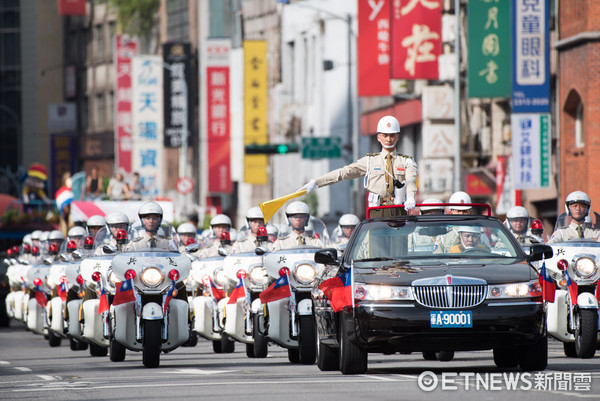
left=345, top=216, right=522, bottom=264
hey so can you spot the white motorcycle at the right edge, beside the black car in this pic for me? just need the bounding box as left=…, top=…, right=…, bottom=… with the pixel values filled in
left=540, top=239, right=600, bottom=358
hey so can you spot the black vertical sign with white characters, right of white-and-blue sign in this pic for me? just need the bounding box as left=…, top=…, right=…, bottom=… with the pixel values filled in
left=163, top=43, right=192, bottom=148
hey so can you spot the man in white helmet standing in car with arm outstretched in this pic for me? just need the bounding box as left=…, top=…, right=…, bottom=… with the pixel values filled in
left=300, top=116, right=417, bottom=217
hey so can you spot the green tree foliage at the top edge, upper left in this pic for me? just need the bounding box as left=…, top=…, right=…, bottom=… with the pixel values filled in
left=109, top=0, right=160, bottom=36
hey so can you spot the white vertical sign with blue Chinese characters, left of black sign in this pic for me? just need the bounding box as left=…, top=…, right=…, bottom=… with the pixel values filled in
left=131, top=56, right=164, bottom=197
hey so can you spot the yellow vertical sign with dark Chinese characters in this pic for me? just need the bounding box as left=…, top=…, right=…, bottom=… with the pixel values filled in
left=244, top=40, right=269, bottom=185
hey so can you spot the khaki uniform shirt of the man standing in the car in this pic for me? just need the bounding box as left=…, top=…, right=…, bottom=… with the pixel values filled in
left=315, top=150, right=417, bottom=202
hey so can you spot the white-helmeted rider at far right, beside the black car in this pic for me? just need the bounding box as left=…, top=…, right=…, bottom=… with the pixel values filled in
left=548, top=191, right=600, bottom=244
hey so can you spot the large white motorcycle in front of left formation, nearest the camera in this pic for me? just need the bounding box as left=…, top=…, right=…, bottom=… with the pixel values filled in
left=111, top=223, right=191, bottom=368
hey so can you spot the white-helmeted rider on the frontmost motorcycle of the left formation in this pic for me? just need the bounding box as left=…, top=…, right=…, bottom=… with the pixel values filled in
left=125, top=201, right=172, bottom=252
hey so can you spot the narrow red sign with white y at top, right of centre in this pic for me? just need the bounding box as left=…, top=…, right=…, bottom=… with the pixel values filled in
left=357, top=0, right=392, bottom=96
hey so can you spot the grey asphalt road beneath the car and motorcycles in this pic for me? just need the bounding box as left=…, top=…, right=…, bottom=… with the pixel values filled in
left=0, top=321, right=600, bottom=401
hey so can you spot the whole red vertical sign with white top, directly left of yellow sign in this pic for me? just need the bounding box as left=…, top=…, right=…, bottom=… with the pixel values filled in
left=205, top=39, right=233, bottom=194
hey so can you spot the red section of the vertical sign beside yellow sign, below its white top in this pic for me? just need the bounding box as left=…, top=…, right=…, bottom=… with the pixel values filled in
left=206, top=66, right=233, bottom=193
